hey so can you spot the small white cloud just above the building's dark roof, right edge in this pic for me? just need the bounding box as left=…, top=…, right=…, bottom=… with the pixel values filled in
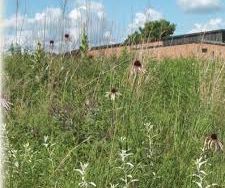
left=190, top=18, right=225, bottom=33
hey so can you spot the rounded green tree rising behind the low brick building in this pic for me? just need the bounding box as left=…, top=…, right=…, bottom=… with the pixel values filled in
left=124, top=19, right=176, bottom=44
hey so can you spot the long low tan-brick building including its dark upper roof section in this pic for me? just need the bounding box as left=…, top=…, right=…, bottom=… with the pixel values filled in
left=86, top=29, right=225, bottom=59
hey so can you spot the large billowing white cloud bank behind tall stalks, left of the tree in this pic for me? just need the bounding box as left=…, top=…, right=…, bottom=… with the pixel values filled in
left=4, top=1, right=113, bottom=51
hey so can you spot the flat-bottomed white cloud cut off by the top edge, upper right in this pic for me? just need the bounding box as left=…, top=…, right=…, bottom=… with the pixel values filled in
left=178, top=0, right=222, bottom=13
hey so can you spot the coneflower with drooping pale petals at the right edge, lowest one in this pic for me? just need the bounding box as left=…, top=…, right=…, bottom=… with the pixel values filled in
left=203, top=133, right=223, bottom=151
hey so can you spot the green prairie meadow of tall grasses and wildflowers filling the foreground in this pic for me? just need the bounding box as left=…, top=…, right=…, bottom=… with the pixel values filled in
left=4, top=46, right=225, bottom=188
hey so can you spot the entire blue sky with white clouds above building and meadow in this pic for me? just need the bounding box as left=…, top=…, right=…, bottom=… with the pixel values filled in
left=4, top=0, right=225, bottom=51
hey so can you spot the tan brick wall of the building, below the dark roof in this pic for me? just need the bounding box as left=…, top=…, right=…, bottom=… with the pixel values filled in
left=89, top=43, right=225, bottom=59
